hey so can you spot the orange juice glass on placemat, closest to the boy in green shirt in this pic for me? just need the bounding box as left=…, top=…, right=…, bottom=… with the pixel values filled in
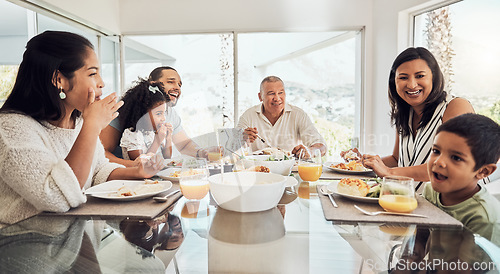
left=378, top=176, right=417, bottom=213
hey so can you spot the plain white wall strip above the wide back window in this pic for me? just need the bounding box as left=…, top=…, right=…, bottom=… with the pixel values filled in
left=120, top=0, right=372, bottom=34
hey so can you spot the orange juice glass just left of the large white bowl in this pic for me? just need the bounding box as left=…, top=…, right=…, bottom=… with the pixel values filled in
left=179, top=158, right=209, bottom=201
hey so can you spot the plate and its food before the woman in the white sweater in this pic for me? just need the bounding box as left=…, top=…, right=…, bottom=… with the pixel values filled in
left=85, top=179, right=172, bottom=201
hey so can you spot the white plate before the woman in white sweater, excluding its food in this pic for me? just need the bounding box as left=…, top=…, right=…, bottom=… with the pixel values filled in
left=85, top=180, right=172, bottom=201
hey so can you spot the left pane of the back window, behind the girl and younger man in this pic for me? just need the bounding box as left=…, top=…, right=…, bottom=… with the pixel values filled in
left=125, top=34, right=234, bottom=143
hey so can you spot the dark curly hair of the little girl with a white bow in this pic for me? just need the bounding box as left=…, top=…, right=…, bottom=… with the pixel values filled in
left=118, top=78, right=170, bottom=131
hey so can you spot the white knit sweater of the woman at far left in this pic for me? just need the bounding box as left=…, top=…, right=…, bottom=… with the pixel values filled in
left=0, top=113, right=121, bottom=224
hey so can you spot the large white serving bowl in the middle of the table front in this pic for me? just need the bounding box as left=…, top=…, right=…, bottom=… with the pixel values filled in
left=208, top=172, right=286, bottom=212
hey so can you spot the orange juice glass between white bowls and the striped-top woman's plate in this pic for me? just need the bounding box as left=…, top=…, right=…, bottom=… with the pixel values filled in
left=298, top=149, right=323, bottom=182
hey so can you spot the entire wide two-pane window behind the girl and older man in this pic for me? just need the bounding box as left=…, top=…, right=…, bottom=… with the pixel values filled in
left=124, top=32, right=361, bottom=159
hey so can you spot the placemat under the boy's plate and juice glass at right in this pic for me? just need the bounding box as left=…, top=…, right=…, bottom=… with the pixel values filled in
left=317, top=185, right=463, bottom=227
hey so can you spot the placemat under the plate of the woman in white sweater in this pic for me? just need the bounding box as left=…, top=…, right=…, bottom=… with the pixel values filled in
left=40, top=185, right=182, bottom=219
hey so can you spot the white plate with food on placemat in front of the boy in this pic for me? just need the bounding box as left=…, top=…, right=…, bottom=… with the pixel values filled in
left=327, top=178, right=380, bottom=203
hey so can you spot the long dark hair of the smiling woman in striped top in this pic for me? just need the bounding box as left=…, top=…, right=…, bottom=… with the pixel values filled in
left=389, top=47, right=446, bottom=136
